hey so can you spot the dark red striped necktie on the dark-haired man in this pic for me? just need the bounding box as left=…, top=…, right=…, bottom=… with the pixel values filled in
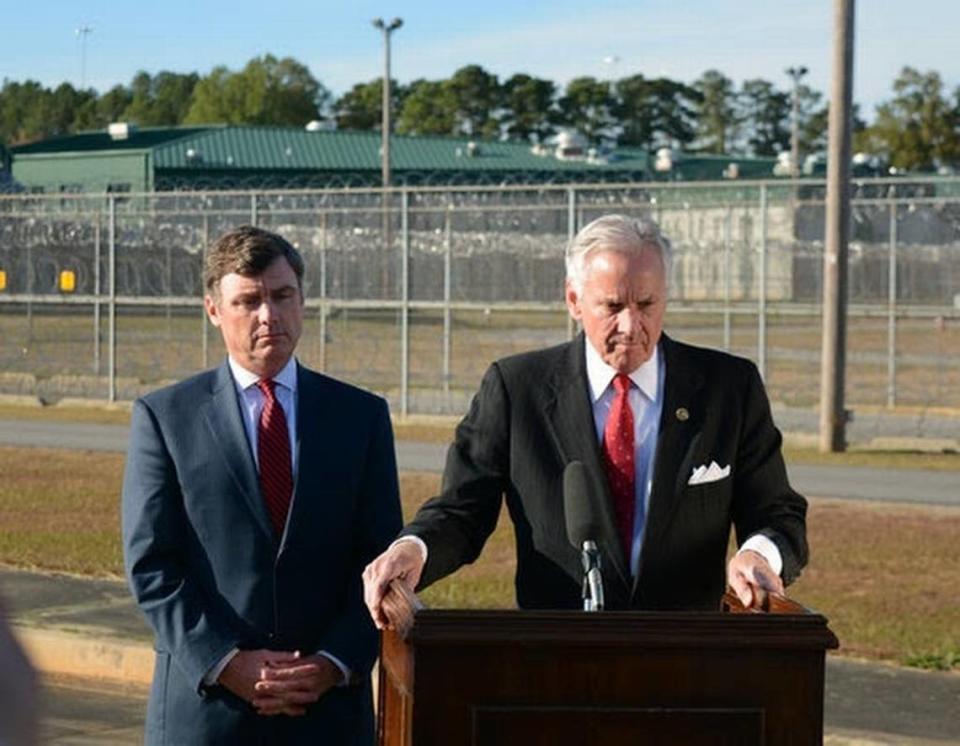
left=257, top=379, right=293, bottom=536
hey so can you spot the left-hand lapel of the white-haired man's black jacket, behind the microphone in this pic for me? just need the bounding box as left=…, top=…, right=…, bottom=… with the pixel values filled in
left=546, top=333, right=630, bottom=589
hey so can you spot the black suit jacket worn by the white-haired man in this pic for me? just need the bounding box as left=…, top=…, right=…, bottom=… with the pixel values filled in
left=403, top=334, right=807, bottom=609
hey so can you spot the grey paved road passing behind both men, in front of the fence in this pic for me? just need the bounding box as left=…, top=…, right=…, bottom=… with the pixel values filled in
left=0, top=420, right=960, bottom=506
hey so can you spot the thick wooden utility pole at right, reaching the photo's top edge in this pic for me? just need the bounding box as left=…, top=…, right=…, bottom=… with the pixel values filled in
left=820, top=0, right=854, bottom=453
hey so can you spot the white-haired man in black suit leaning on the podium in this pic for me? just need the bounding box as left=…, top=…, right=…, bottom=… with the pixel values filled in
left=364, top=215, right=807, bottom=616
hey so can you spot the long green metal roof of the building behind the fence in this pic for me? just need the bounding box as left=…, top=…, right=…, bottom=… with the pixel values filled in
left=11, top=125, right=804, bottom=181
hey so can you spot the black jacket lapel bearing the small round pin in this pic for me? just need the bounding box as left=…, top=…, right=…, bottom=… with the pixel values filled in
left=637, top=335, right=704, bottom=560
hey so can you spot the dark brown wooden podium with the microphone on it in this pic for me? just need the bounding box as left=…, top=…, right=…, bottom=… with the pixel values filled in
left=378, top=595, right=838, bottom=746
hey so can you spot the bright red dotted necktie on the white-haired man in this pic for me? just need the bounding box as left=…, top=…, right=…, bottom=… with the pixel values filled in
left=603, top=373, right=637, bottom=559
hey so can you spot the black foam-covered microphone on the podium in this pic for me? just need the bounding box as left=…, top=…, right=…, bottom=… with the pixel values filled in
left=563, top=461, right=604, bottom=611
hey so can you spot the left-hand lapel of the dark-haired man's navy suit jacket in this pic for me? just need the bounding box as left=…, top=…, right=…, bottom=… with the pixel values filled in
left=203, top=361, right=275, bottom=541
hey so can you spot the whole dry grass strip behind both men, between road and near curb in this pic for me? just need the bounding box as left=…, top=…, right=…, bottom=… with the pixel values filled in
left=0, top=448, right=960, bottom=668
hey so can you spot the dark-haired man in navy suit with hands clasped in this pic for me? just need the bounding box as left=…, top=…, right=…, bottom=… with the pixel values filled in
left=123, top=227, right=400, bottom=746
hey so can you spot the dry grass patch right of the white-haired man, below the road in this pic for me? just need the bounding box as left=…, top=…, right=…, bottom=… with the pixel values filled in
left=790, top=500, right=960, bottom=668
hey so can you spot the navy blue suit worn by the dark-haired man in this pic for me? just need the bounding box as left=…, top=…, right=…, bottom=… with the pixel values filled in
left=123, top=363, right=401, bottom=746
